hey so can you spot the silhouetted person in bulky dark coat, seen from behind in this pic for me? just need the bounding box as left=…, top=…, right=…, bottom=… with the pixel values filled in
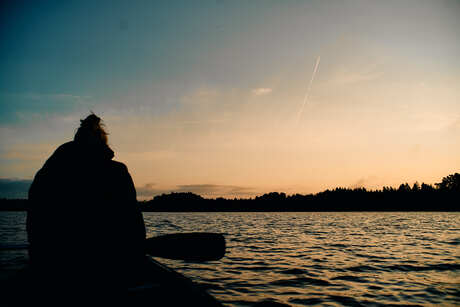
left=27, top=114, right=145, bottom=305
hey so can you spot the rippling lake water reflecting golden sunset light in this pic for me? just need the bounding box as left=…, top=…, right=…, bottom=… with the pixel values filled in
left=0, top=212, right=460, bottom=306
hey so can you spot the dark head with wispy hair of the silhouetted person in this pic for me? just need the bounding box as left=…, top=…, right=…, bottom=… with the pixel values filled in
left=74, top=113, right=108, bottom=145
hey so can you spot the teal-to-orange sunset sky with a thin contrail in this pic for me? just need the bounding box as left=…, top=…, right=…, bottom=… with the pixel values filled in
left=0, top=0, right=460, bottom=198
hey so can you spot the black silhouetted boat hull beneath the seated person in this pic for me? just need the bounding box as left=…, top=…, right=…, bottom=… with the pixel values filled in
left=0, top=257, right=224, bottom=307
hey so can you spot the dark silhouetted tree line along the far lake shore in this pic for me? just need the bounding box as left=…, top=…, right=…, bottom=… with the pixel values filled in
left=0, top=173, right=460, bottom=212
